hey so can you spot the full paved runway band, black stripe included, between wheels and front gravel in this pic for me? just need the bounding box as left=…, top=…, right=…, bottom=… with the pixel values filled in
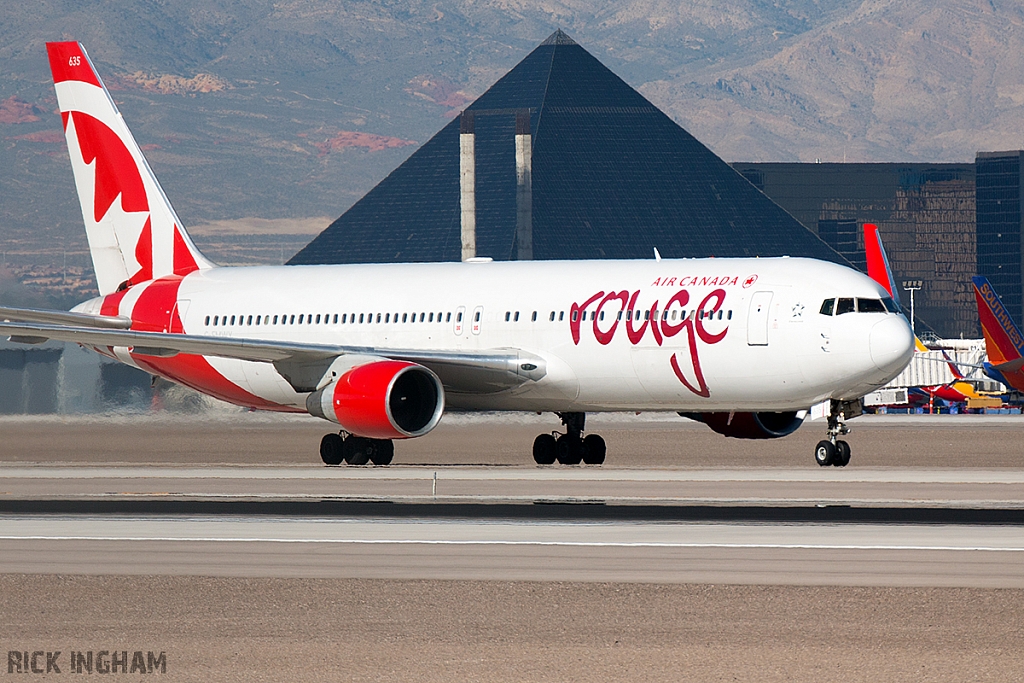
left=0, top=458, right=1024, bottom=588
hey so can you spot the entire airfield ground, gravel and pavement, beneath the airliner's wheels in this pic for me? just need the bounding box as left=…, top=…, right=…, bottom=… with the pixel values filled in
left=0, top=414, right=1024, bottom=681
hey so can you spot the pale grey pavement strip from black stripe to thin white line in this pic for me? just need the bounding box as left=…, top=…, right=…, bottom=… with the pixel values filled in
left=0, top=515, right=1024, bottom=552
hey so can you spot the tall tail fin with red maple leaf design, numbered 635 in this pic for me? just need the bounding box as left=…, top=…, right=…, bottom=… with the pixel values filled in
left=46, top=42, right=213, bottom=295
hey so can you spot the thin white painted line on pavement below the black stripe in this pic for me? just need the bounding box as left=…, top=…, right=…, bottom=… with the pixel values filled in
left=0, top=536, right=1024, bottom=553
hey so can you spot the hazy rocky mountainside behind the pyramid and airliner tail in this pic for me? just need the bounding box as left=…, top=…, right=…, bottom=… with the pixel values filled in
left=0, top=0, right=1024, bottom=305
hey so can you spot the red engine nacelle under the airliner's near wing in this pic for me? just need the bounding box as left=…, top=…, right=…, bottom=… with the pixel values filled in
left=306, top=359, right=444, bottom=438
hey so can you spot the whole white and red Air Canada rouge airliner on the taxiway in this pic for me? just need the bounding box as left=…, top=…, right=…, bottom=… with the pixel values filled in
left=0, top=42, right=913, bottom=466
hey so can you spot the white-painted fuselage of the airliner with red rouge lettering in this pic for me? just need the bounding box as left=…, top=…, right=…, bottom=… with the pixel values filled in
left=78, top=258, right=913, bottom=412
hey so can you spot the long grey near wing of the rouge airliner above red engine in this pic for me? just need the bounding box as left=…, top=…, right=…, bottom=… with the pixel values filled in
left=0, top=321, right=546, bottom=394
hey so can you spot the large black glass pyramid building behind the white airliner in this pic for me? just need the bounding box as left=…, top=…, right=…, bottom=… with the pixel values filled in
left=289, top=31, right=845, bottom=264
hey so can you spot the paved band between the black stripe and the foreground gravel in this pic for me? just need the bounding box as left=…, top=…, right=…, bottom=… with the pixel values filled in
left=6, top=516, right=1024, bottom=588
